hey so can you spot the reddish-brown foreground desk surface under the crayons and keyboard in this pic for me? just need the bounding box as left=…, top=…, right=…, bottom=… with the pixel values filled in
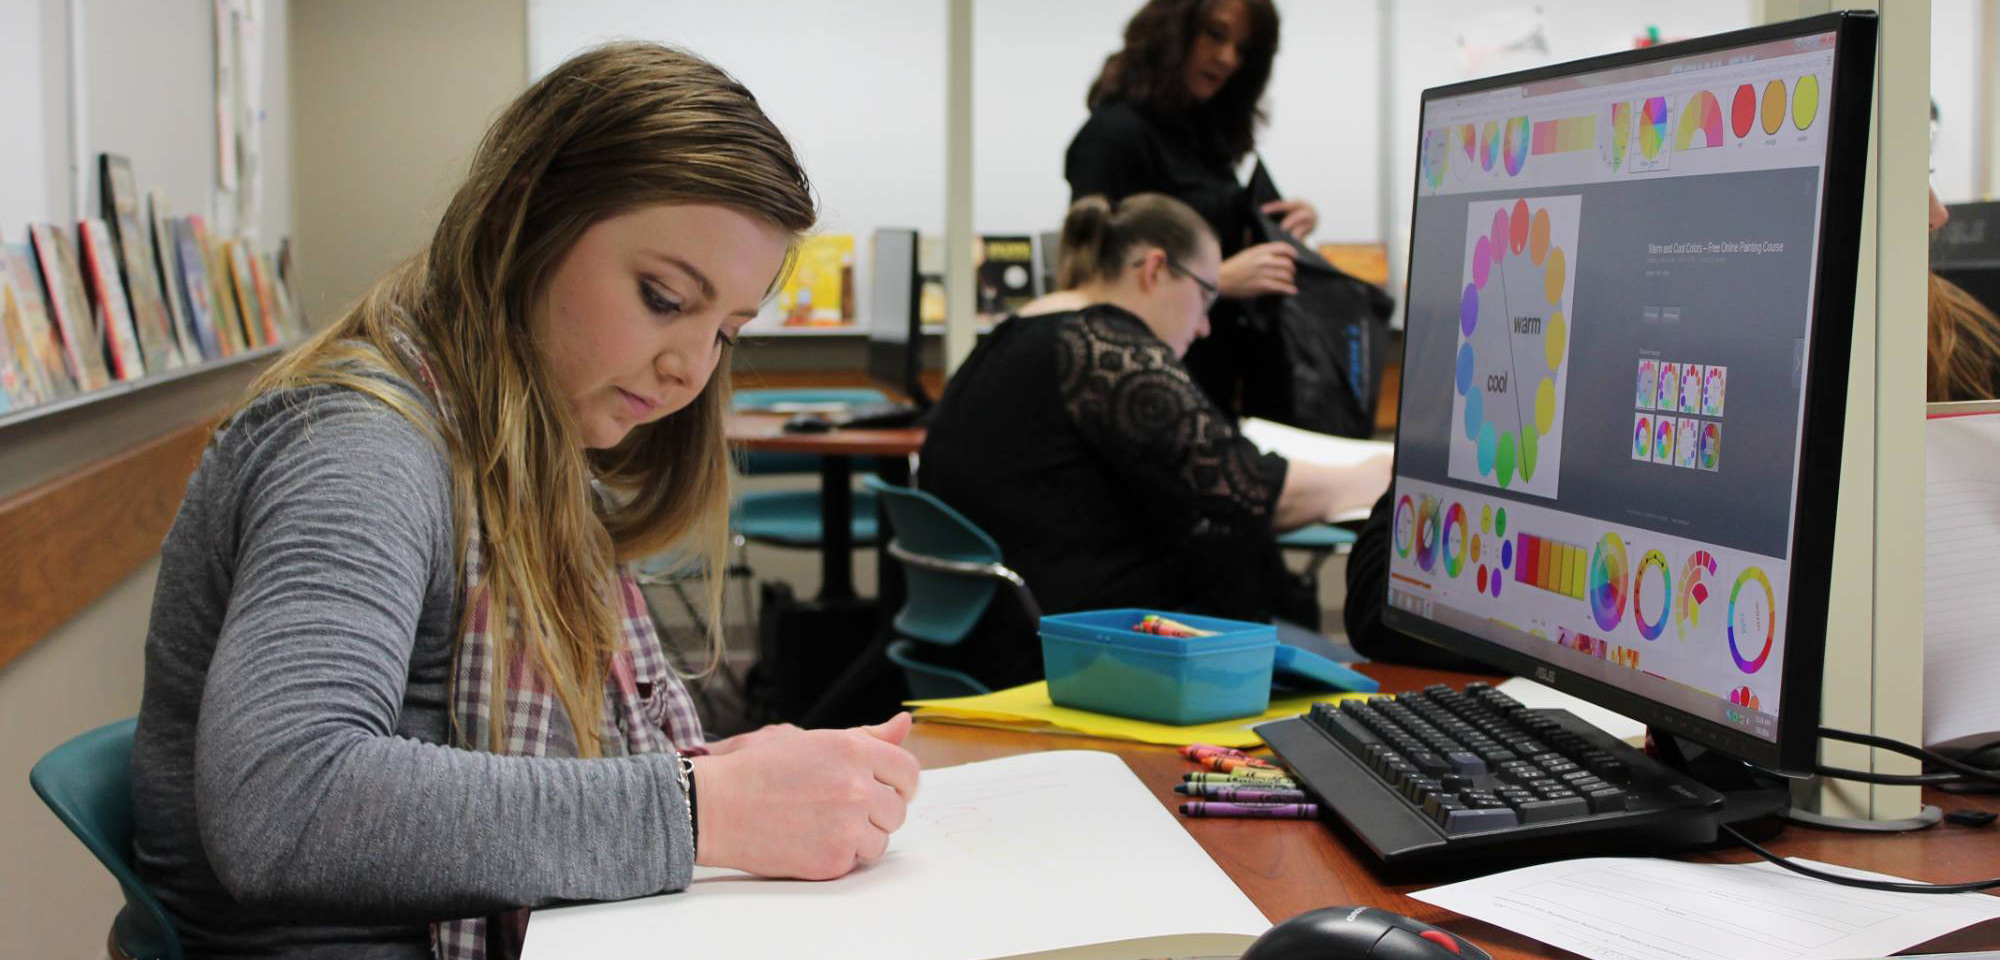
left=906, top=664, right=2000, bottom=960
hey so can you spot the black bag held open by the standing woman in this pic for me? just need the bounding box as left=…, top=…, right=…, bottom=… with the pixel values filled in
left=1248, top=160, right=1396, bottom=438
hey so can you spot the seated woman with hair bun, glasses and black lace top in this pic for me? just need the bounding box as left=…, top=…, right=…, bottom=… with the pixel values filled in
left=918, top=194, right=1388, bottom=686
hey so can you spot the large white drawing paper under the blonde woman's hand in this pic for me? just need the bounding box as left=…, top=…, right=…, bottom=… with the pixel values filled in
left=524, top=750, right=1270, bottom=960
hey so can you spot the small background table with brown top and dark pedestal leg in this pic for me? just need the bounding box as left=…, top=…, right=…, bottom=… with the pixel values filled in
left=724, top=412, right=924, bottom=600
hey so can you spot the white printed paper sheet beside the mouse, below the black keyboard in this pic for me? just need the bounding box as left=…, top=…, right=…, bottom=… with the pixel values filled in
left=1410, top=858, right=2000, bottom=960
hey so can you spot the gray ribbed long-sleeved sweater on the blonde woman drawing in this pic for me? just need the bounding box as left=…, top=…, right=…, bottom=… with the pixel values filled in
left=132, top=382, right=694, bottom=958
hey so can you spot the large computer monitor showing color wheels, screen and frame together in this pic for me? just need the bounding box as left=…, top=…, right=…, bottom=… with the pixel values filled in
left=1384, top=14, right=1876, bottom=776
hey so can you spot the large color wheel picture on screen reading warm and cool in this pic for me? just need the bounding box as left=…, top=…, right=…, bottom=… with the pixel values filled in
left=1448, top=194, right=1582, bottom=498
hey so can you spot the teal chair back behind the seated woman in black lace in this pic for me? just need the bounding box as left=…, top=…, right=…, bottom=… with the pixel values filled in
left=866, top=478, right=1042, bottom=700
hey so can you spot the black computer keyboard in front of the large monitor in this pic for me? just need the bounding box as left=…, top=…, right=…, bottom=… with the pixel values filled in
left=1256, top=684, right=1722, bottom=862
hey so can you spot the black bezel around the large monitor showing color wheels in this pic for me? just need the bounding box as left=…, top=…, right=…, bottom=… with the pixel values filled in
left=1382, top=12, right=1878, bottom=776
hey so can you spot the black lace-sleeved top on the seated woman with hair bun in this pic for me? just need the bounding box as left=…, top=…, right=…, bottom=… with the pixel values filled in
left=918, top=306, right=1296, bottom=682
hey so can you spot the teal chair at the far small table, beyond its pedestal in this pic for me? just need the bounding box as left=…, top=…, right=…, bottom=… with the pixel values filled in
left=730, top=388, right=888, bottom=550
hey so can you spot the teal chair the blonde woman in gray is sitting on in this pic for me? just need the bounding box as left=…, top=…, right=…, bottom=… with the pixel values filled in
left=28, top=718, right=184, bottom=960
